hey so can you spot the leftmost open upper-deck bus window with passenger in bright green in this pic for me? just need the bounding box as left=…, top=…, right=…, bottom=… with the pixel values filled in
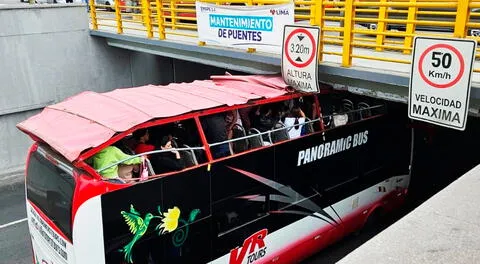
left=86, top=119, right=207, bottom=183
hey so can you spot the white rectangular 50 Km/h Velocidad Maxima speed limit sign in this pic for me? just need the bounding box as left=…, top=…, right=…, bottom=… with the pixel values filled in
left=408, top=37, right=477, bottom=130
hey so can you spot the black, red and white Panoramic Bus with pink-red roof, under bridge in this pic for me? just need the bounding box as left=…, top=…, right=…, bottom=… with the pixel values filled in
left=17, top=75, right=411, bottom=264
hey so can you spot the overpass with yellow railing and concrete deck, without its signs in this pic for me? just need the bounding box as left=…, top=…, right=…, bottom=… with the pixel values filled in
left=90, top=0, right=480, bottom=115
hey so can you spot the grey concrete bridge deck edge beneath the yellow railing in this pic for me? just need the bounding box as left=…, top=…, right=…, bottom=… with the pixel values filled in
left=90, top=26, right=480, bottom=115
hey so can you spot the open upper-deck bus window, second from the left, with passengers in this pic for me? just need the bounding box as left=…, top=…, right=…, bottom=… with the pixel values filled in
left=201, top=96, right=320, bottom=158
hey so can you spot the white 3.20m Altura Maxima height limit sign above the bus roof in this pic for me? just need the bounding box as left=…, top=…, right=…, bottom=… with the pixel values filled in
left=282, top=25, right=320, bottom=92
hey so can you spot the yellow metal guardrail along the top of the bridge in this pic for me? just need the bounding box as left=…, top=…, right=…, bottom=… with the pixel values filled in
left=90, top=0, right=480, bottom=72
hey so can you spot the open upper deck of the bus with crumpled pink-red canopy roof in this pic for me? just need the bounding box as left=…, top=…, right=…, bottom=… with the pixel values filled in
left=18, top=75, right=385, bottom=184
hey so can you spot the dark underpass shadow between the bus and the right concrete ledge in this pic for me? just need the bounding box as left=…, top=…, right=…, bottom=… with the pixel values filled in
left=304, top=103, right=480, bottom=264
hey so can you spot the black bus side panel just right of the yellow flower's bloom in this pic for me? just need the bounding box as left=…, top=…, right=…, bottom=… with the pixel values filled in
left=161, top=166, right=212, bottom=263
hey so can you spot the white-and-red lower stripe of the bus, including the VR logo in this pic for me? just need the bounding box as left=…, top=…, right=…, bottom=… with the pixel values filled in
left=210, top=178, right=404, bottom=264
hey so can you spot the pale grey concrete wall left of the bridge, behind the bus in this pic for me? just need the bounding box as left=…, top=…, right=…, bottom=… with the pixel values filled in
left=0, top=5, right=173, bottom=184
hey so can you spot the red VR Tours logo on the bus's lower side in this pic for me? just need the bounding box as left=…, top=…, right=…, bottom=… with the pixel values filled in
left=230, top=229, right=268, bottom=264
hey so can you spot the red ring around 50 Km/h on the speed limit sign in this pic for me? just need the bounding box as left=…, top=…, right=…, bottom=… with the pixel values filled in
left=418, top=44, right=465, bottom=89
